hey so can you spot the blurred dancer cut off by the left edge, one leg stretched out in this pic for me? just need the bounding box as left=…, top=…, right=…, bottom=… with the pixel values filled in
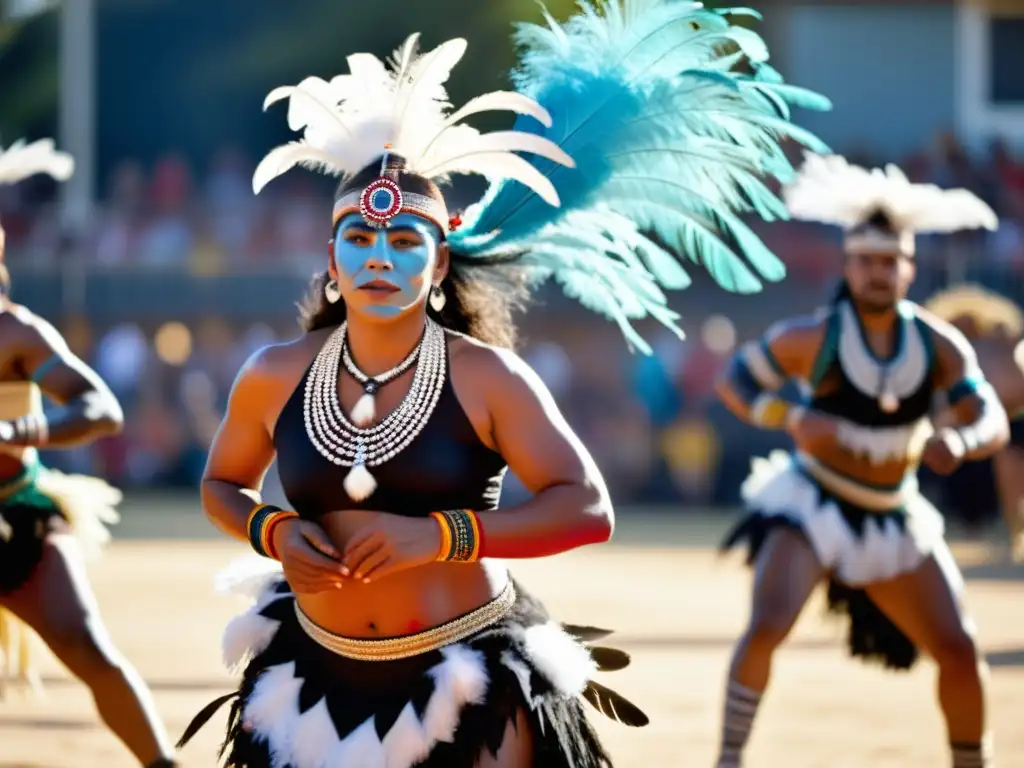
left=0, top=139, right=174, bottom=768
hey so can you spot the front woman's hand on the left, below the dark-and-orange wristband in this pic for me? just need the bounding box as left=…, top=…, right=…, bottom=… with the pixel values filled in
left=273, top=518, right=345, bottom=594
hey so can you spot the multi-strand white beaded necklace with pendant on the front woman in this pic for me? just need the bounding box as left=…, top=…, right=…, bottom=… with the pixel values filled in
left=302, top=318, right=447, bottom=502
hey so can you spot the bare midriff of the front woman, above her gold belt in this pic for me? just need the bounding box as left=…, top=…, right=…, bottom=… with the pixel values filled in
left=297, top=510, right=508, bottom=640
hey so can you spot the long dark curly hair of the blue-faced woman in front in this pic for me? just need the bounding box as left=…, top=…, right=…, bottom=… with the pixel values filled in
left=299, top=155, right=527, bottom=348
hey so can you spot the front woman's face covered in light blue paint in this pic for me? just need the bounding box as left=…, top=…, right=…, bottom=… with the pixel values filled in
left=334, top=213, right=440, bottom=317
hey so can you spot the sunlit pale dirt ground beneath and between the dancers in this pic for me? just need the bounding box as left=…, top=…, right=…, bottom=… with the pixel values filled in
left=0, top=541, right=1024, bottom=768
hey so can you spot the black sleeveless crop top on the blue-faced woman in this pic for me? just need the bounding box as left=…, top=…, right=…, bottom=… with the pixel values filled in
left=273, top=337, right=507, bottom=520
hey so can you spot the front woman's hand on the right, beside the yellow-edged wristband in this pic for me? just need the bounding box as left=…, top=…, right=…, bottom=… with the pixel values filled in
left=341, top=512, right=441, bottom=582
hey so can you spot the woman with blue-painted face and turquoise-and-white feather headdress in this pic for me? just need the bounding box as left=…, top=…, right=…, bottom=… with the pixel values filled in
left=182, top=2, right=827, bottom=768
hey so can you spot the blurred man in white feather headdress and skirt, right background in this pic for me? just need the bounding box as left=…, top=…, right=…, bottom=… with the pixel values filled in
left=718, top=156, right=1009, bottom=768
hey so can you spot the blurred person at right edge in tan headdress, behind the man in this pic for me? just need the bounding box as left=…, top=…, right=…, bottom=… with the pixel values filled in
left=925, top=285, right=1024, bottom=562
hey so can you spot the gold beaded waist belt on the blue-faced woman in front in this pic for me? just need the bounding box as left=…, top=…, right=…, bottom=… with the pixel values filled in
left=295, top=582, right=515, bottom=662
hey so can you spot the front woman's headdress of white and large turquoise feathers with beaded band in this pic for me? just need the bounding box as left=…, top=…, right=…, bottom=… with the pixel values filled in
left=253, top=0, right=830, bottom=352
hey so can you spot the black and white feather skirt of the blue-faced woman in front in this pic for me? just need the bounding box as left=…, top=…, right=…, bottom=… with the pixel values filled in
left=179, top=578, right=647, bottom=768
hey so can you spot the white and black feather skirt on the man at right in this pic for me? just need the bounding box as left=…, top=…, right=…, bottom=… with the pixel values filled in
left=722, top=452, right=955, bottom=670
